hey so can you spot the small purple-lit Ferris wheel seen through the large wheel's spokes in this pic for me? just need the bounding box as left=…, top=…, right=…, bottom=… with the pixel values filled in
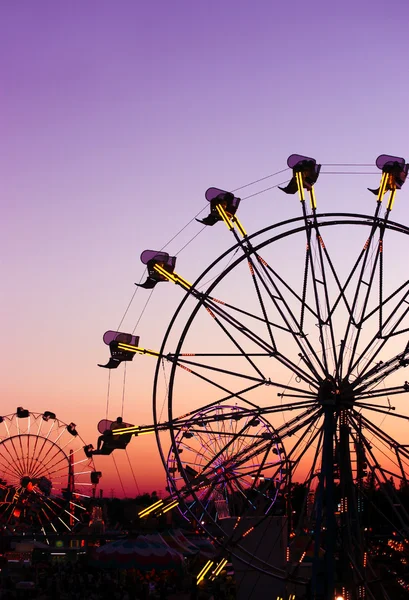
left=167, top=404, right=287, bottom=524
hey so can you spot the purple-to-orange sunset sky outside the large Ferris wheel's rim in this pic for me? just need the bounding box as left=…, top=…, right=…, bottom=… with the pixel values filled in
left=0, top=0, right=409, bottom=496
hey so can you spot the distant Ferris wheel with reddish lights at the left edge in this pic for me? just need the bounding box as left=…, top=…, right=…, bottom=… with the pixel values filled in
left=0, top=407, right=101, bottom=535
